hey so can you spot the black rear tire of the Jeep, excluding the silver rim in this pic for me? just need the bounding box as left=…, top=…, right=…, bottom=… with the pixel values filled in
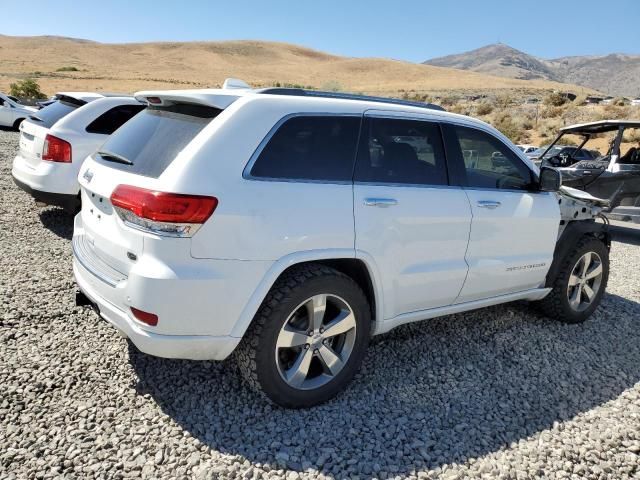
left=235, top=264, right=371, bottom=408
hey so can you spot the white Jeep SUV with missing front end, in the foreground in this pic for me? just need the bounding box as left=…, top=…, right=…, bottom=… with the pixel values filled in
left=73, top=81, right=609, bottom=407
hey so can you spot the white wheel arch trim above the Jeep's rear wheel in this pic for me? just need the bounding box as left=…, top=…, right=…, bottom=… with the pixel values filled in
left=231, top=250, right=383, bottom=337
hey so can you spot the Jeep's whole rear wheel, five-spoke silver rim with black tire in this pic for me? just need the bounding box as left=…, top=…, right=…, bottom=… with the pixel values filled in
left=236, top=264, right=371, bottom=408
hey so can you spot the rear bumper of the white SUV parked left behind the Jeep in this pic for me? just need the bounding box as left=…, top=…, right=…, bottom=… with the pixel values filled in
left=11, top=155, right=80, bottom=212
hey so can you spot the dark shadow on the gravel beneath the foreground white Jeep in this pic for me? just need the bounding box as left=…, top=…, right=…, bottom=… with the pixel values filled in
left=129, top=295, right=640, bottom=478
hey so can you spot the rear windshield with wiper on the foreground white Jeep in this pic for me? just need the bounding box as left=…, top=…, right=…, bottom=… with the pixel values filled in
left=96, top=104, right=221, bottom=178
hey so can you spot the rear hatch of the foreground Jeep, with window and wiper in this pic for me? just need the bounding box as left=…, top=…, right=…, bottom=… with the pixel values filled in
left=74, top=98, right=221, bottom=278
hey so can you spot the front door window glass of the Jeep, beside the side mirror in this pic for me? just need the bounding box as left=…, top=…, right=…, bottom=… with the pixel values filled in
left=453, top=126, right=533, bottom=190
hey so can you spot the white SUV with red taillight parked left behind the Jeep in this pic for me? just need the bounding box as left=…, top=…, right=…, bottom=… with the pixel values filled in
left=11, top=93, right=145, bottom=213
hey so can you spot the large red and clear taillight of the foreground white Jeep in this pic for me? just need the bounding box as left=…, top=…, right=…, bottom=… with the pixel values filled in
left=111, top=185, right=218, bottom=237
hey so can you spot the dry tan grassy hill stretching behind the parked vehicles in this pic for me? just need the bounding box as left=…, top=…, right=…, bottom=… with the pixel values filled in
left=0, top=35, right=588, bottom=95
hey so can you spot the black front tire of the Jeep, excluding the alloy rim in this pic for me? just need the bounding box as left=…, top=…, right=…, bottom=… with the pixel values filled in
left=537, top=236, right=609, bottom=323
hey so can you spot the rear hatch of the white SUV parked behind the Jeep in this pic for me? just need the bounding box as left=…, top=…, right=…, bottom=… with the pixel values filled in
left=20, top=95, right=87, bottom=168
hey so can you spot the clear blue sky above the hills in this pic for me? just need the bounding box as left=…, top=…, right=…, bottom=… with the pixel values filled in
left=0, top=0, right=640, bottom=62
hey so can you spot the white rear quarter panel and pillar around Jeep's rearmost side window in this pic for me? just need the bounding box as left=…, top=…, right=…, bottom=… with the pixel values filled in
left=162, top=96, right=361, bottom=260
